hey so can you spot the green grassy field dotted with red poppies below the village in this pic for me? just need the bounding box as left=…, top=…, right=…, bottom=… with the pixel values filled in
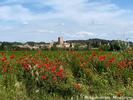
left=0, top=50, right=133, bottom=100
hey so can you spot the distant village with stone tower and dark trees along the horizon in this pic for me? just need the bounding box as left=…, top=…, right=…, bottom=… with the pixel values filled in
left=0, top=36, right=133, bottom=51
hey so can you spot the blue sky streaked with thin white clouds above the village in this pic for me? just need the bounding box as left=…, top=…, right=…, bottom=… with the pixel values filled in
left=0, top=0, right=133, bottom=42
